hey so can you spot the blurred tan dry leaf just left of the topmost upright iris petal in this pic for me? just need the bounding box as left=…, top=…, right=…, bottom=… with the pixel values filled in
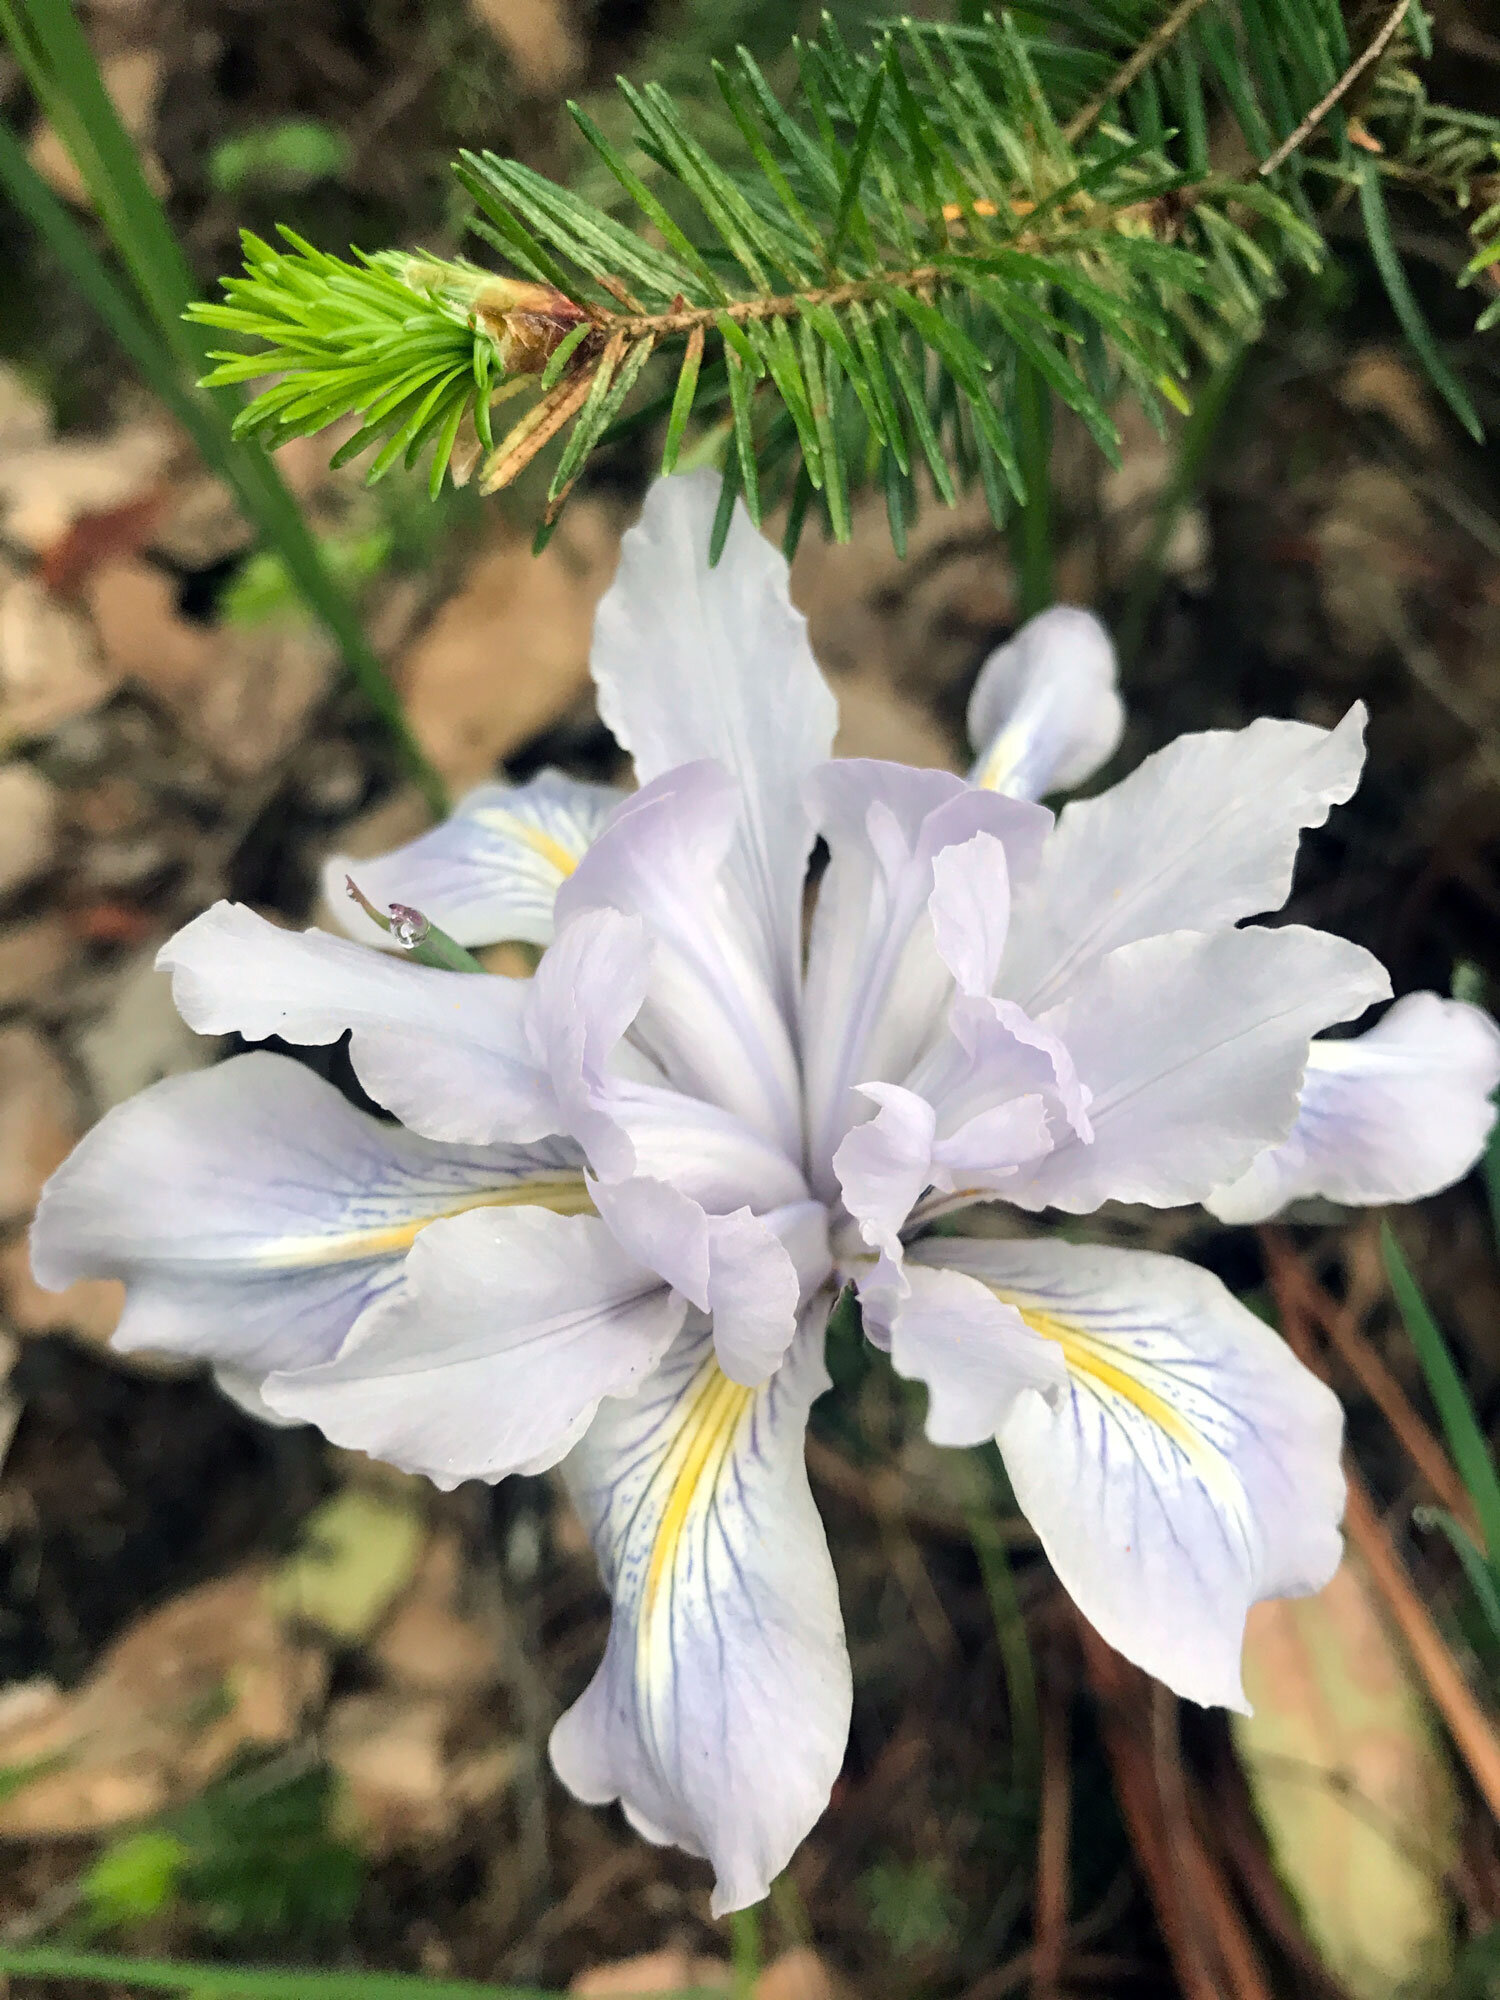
left=402, top=500, right=620, bottom=790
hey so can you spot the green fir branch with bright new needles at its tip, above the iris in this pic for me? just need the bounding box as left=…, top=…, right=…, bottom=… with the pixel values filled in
left=192, top=0, right=1500, bottom=574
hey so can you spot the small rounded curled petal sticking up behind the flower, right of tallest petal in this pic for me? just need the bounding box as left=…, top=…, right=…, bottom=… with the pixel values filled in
left=968, top=604, right=1124, bottom=798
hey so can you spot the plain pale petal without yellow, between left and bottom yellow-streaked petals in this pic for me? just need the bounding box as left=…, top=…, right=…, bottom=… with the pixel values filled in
left=262, top=1208, right=686, bottom=1488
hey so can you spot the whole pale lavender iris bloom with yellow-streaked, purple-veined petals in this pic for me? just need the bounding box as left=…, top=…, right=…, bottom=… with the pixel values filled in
left=32, top=474, right=1500, bottom=1910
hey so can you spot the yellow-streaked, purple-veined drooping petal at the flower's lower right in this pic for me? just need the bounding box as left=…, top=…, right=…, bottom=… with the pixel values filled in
left=910, top=1236, right=1344, bottom=1710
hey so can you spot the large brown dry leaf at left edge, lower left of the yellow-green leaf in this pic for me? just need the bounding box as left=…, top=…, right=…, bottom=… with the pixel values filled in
left=0, top=1568, right=328, bottom=1836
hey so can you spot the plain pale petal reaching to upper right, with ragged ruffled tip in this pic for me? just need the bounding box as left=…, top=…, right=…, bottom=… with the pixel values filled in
left=1000, top=702, right=1364, bottom=1014
